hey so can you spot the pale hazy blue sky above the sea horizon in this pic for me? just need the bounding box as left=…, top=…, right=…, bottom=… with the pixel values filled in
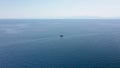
left=0, top=0, right=120, bottom=19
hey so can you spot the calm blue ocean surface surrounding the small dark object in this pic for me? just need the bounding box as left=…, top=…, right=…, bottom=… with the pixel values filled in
left=0, top=19, right=120, bottom=68
